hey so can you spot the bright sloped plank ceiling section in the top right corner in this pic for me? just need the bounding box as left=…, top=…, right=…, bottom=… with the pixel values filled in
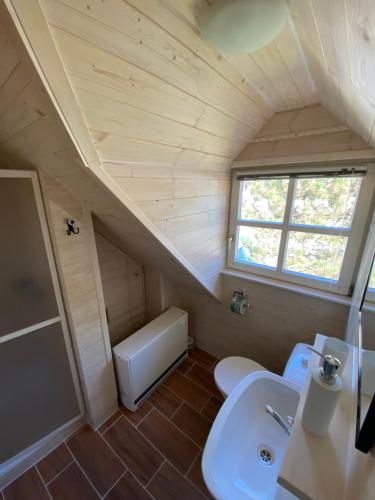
left=287, top=0, right=375, bottom=147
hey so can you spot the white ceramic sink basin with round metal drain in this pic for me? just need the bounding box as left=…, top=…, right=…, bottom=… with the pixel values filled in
left=202, top=371, right=299, bottom=500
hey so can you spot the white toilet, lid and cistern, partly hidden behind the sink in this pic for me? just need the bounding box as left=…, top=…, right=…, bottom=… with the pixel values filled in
left=214, top=343, right=311, bottom=398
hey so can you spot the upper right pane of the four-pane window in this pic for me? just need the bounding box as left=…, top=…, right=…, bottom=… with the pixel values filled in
left=291, top=177, right=361, bottom=228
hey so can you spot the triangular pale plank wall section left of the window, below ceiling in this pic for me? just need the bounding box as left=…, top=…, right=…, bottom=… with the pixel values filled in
left=105, top=165, right=230, bottom=281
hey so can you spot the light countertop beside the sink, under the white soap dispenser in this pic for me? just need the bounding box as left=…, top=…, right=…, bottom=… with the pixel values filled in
left=278, top=334, right=356, bottom=500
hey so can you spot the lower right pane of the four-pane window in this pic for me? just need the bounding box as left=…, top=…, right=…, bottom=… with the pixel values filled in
left=284, top=231, right=347, bottom=281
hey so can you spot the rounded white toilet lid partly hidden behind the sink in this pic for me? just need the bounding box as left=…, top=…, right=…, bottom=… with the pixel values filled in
left=215, top=356, right=268, bottom=395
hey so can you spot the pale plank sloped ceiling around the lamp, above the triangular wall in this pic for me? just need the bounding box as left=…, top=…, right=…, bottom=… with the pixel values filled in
left=42, top=0, right=317, bottom=164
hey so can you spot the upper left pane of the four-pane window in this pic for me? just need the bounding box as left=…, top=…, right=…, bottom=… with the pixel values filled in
left=240, top=179, right=289, bottom=222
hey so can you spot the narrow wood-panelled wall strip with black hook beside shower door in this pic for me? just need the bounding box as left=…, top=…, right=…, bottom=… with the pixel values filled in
left=39, top=172, right=117, bottom=428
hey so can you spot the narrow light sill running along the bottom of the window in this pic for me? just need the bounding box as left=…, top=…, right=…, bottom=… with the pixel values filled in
left=221, top=267, right=352, bottom=307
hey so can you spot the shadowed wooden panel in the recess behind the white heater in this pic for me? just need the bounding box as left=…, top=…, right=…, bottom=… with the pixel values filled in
left=95, top=231, right=146, bottom=347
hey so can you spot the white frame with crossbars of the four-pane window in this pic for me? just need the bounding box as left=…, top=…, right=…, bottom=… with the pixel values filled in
left=227, top=163, right=375, bottom=295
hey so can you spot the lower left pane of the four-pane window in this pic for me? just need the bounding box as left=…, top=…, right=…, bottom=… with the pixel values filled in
left=236, top=226, right=281, bottom=267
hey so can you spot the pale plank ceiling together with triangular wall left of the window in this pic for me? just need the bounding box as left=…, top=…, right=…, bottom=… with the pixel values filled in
left=29, top=0, right=317, bottom=290
